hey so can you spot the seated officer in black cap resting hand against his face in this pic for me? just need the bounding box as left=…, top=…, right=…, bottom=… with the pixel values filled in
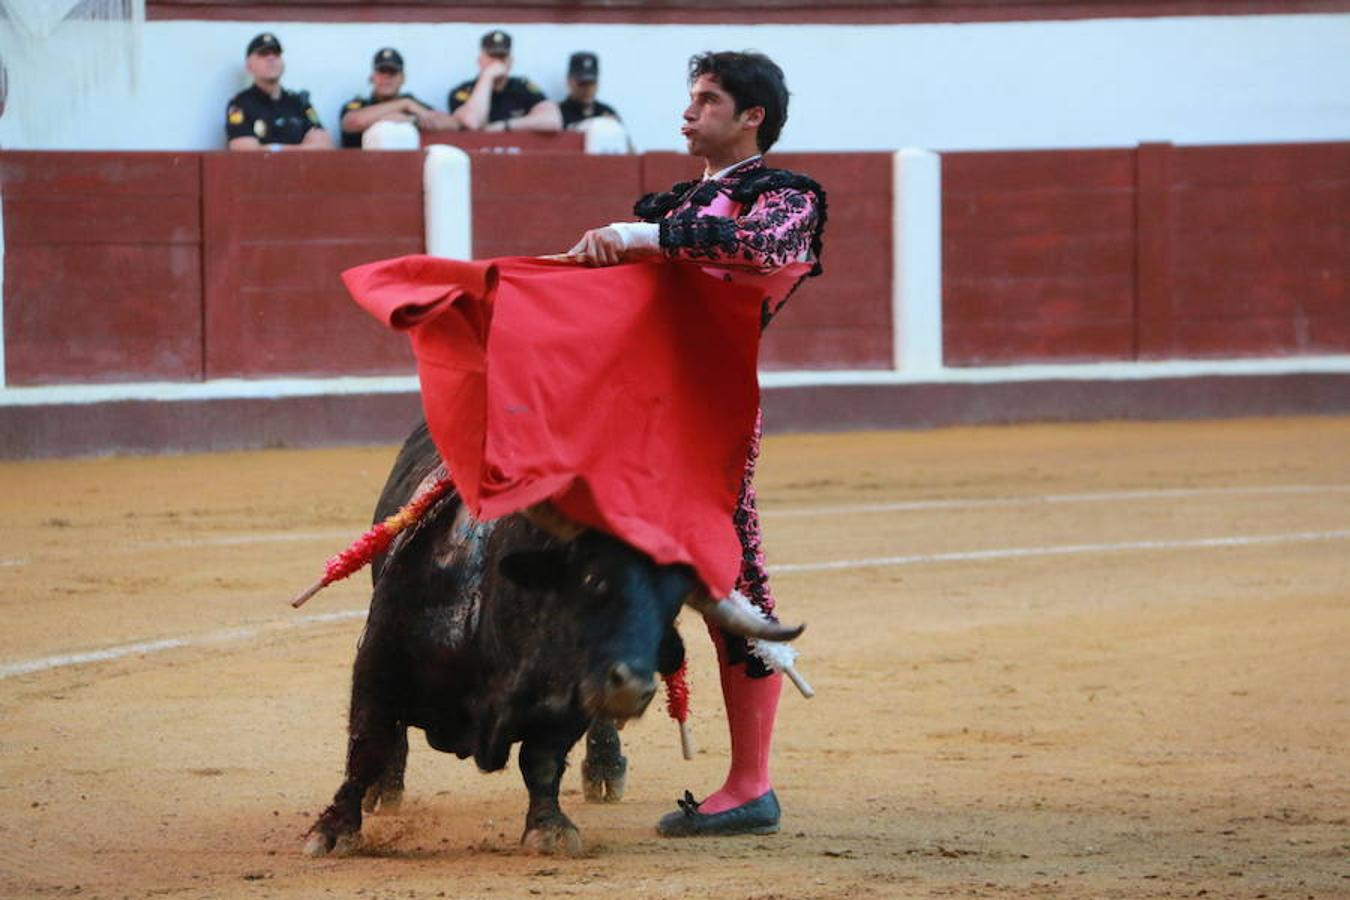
left=447, top=31, right=563, bottom=131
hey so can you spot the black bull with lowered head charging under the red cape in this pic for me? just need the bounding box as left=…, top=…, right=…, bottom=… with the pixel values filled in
left=305, top=425, right=801, bottom=855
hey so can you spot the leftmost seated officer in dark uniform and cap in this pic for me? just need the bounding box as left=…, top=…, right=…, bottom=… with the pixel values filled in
left=225, top=31, right=333, bottom=150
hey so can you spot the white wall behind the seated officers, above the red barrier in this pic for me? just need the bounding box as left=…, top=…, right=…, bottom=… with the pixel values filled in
left=0, top=15, right=1350, bottom=150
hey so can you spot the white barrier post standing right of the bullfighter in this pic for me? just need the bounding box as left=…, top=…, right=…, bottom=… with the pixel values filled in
left=891, top=148, right=942, bottom=375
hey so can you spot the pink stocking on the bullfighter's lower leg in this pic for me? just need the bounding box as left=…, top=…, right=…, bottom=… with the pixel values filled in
left=698, top=627, right=783, bottom=815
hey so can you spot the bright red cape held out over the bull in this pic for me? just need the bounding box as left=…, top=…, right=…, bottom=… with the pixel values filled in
left=343, top=256, right=761, bottom=596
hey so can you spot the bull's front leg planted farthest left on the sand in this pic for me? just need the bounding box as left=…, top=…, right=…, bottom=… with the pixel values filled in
left=305, top=642, right=394, bottom=857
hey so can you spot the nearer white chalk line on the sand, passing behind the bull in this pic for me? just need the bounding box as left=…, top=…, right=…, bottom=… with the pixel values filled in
left=0, top=530, right=1350, bottom=680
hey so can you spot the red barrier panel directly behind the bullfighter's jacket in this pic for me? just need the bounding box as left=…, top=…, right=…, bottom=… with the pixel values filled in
left=643, top=152, right=892, bottom=370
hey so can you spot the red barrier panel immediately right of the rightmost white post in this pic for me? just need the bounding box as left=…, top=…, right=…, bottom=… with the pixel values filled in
left=942, top=150, right=1134, bottom=366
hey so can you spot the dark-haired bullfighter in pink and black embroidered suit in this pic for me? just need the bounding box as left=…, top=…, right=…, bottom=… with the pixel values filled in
left=568, top=51, right=826, bottom=837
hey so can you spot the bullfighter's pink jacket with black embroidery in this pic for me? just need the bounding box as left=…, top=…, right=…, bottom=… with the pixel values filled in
left=633, top=159, right=826, bottom=327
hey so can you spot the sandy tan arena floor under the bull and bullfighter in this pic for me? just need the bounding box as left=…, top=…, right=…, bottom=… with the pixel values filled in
left=0, top=420, right=1350, bottom=900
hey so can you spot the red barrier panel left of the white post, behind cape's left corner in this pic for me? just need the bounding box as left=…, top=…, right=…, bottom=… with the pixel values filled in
left=203, top=152, right=425, bottom=378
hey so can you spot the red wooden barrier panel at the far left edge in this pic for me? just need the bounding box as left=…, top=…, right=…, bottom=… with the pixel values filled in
left=0, top=152, right=203, bottom=385
